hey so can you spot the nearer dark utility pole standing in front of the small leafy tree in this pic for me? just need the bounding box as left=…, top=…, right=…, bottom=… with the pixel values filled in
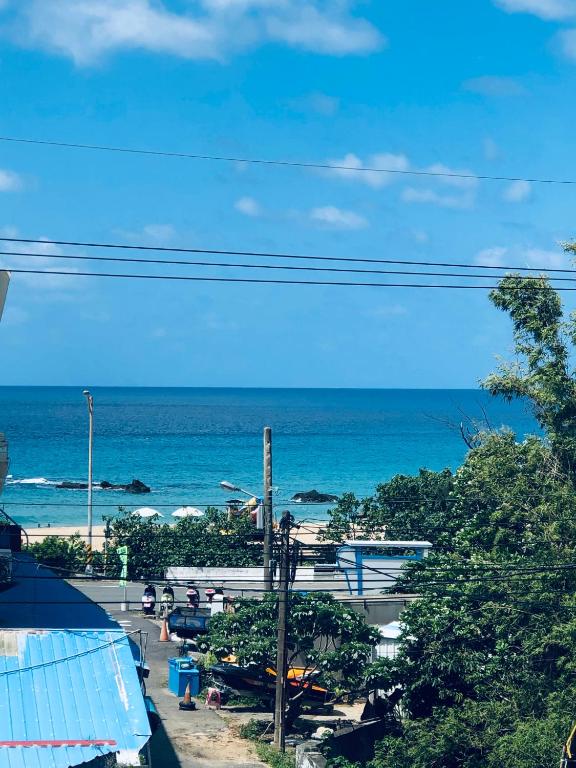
left=274, top=511, right=292, bottom=752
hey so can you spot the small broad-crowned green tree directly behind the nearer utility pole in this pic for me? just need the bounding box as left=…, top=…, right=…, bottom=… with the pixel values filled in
left=201, top=592, right=379, bottom=721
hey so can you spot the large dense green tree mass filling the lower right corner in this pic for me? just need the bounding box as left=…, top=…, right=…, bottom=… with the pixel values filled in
left=366, top=432, right=576, bottom=768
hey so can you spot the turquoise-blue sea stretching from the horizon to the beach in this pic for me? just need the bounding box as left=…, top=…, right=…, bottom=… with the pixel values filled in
left=0, top=387, right=537, bottom=525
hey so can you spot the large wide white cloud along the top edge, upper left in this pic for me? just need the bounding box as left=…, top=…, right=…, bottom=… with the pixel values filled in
left=7, top=0, right=385, bottom=66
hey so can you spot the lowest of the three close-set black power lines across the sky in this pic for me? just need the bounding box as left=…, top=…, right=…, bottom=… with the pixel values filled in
left=10, top=269, right=576, bottom=291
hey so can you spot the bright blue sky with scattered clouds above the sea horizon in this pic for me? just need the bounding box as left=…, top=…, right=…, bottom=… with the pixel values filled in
left=0, top=0, right=576, bottom=387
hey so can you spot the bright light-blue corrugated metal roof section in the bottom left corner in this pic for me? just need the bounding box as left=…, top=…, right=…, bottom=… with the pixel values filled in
left=0, top=629, right=150, bottom=768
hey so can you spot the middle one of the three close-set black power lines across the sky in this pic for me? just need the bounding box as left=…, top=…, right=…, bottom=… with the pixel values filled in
left=0, top=251, right=576, bottom=283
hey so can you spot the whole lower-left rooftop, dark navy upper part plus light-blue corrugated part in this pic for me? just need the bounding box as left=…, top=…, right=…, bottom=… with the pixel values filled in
left=0, top=553, right=150, bottom=768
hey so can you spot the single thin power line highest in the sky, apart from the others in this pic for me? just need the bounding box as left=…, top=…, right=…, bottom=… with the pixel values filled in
left=0, top=136, right=576, bottom=185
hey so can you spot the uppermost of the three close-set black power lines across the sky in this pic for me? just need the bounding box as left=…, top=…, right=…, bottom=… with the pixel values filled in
left=0, top=237, right=576, bottom=274
